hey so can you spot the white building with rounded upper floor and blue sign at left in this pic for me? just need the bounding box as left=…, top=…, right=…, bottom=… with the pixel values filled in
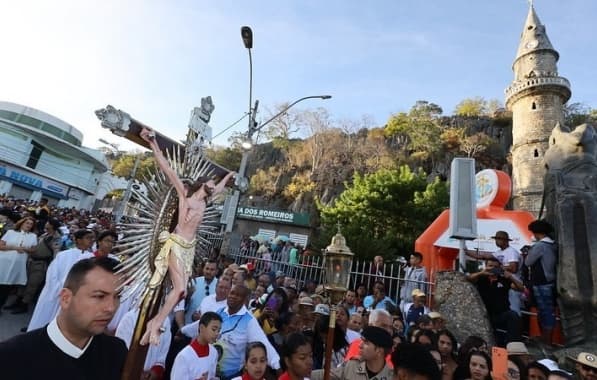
left=0, top=101, right=108, bottom=209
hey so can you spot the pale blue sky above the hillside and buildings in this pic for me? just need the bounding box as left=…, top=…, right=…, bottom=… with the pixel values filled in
left=0, top=0, right=597, bottom=149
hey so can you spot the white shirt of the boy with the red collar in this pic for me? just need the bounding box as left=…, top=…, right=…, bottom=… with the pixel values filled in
left=170, top=344, right=218, bottom=380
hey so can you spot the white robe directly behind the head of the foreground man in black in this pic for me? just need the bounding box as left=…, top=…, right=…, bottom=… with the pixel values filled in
left=27, top=248, right=93, bottom=331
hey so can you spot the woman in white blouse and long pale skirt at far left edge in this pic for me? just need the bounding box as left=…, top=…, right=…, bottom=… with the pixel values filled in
left=0, top=217, right=37, bottom=307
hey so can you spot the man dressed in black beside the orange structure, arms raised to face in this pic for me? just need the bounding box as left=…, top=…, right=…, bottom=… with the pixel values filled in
left=468, top=257, right=523, bottom=347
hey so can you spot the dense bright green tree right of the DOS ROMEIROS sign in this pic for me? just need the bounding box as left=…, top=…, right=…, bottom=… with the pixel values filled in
left=318, top=166, right=449, bottom=258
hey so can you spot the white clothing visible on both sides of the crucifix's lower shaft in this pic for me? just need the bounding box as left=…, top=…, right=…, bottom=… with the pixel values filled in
left=116, top=309, right=172, bottom=371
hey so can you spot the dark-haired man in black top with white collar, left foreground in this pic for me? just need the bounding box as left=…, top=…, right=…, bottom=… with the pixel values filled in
left=0, top=257, right=127, bottom=380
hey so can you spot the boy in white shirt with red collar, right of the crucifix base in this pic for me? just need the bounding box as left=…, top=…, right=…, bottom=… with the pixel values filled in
left=170, top=312, right=222, bottom=380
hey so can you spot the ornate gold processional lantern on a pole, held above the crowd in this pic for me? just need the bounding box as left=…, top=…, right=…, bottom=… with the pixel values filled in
left=323, top=225, right=354, bottom=380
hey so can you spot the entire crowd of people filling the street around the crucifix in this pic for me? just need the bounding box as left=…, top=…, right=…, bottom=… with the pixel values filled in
left=0, top=196, right=597, bottom=380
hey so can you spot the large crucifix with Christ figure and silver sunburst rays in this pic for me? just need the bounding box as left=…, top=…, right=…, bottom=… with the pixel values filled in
left=96, top=97, right=235, bottom=380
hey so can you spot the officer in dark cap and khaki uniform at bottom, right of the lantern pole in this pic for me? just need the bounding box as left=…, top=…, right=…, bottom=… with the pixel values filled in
left=311, top=326, right=393, bottom=380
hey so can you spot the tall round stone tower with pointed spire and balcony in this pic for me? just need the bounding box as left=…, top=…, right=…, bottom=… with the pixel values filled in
left=505, top=5, right=571, bottom=214
